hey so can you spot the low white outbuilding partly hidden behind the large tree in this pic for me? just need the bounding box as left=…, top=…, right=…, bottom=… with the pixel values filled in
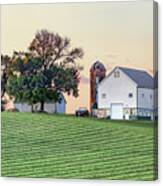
left=14, top=95, right=66, bottom=113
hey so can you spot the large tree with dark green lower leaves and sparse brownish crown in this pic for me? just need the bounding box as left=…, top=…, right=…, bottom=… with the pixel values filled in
left=8, top=30, right=83, bottom=111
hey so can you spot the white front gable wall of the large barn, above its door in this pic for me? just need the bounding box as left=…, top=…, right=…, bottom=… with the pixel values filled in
left=98, top=68, right=137, bottom=109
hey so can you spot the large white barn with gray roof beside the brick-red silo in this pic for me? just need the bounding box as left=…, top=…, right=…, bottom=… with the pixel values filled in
left=97, top=67, right=157, bottom=119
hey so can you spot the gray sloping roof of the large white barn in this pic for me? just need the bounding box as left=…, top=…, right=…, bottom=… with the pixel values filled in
left=119, top=67, right=154, bottom=88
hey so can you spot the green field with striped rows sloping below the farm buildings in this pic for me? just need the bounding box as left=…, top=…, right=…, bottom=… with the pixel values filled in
left=1, top=112, right=157, bottom=180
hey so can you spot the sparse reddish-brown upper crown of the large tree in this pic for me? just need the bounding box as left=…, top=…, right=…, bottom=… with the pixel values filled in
left=29, top=30, right=83, bottom=70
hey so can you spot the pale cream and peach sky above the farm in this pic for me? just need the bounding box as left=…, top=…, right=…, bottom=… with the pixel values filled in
left=1, top=0, right=153, bottom=113
